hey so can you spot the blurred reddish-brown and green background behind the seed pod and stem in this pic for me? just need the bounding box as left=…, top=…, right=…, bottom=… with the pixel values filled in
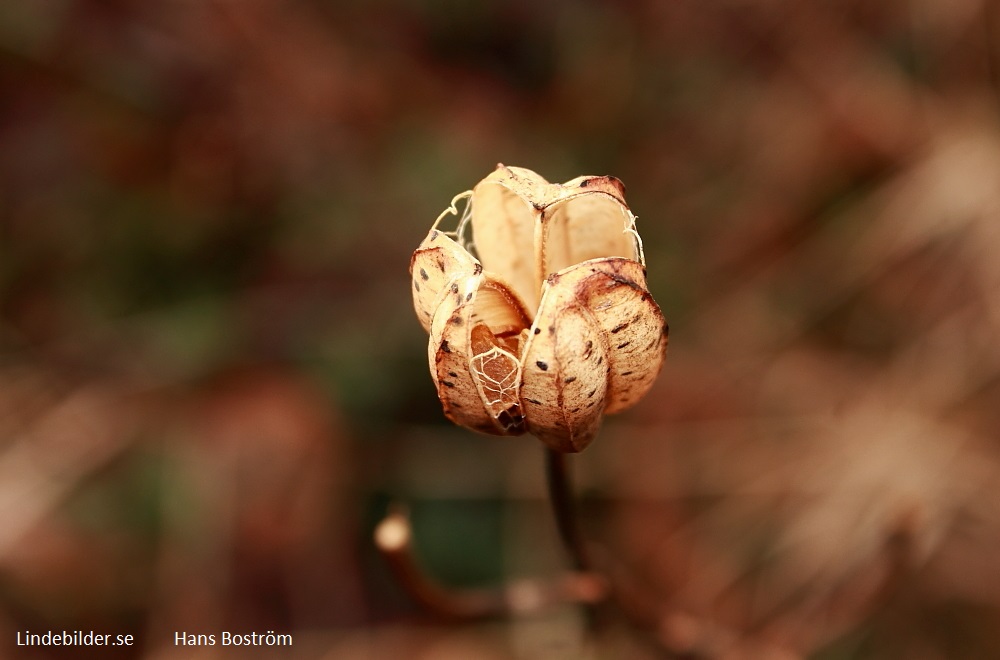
left=0, top=0, right=1000, bottom=660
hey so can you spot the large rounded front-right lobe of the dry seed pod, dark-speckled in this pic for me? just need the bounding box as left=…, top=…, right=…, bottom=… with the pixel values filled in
left=521, top=258, right=666, bottom=451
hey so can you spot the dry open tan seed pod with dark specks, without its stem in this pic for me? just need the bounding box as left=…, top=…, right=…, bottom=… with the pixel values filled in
left=410, top=165, right=667, bottom=452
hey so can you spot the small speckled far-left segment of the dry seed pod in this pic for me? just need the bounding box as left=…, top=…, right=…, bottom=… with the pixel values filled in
left=410, top=229, right=483, bottom=332
